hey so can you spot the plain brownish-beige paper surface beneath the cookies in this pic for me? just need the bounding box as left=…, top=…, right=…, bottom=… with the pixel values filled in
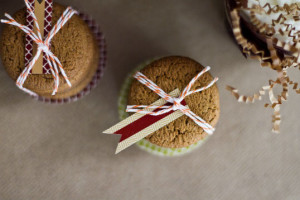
left=0, top=0, right=300, bottom=200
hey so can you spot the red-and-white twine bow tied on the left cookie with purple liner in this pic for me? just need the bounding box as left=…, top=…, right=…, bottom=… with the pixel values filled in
left=1, top=0, right=78, bottom=96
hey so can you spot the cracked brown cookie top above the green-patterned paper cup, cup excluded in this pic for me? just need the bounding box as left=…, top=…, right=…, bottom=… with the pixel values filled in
left=128, top=56, right=220, bottom=148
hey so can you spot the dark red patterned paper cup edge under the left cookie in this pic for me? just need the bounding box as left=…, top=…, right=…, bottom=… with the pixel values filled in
left=33, top=13, right=107, bottom=104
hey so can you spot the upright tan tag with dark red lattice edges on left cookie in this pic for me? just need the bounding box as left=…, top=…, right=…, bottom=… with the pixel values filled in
left=25, top=0, right=53, bottom=74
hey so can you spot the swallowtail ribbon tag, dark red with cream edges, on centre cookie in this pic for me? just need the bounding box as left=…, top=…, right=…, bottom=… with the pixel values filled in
left=103, top=89, right=186, bottom=154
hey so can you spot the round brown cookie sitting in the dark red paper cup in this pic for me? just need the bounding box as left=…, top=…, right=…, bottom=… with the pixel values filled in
left=0, top=3, right=99, bottom=99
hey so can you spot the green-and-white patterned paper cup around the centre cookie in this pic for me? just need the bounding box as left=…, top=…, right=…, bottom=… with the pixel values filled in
left=118, top=59, right=209, bottom=156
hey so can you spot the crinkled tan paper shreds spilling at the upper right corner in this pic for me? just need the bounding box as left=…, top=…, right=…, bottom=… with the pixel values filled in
left=226, top=3, right=300, bottom=133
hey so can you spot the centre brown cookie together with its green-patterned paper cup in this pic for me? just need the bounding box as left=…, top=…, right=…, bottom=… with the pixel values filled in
left=119, top=56, right=220, bottom=156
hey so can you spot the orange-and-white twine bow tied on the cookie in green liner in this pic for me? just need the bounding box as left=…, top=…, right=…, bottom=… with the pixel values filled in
left=126, top=67, right=218, bottom=134
